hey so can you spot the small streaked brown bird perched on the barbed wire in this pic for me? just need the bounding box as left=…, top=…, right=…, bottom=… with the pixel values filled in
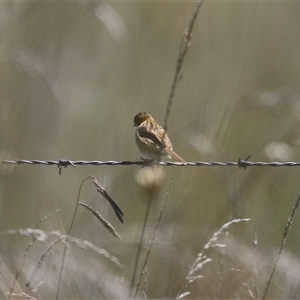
left=133, top=112, right=186, bottom=165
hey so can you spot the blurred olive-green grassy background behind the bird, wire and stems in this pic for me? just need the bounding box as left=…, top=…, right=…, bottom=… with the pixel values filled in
left=0, top=1, right=300, bottom=299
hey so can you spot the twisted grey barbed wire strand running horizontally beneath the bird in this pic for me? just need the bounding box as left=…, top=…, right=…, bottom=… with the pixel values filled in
left=0, top=157, right=300, bottom=174
